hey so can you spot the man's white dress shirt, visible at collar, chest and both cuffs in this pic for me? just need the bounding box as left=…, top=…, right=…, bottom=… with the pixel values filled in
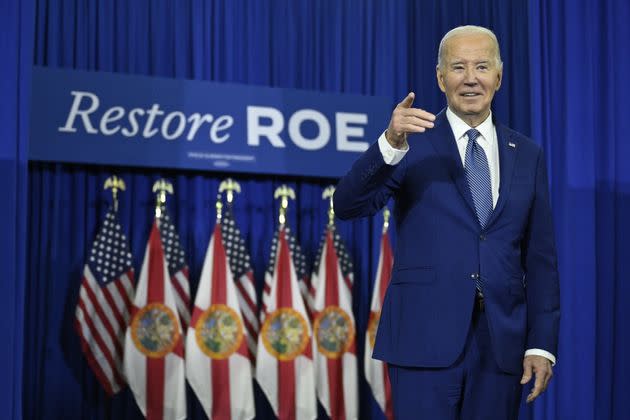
left=378, top=108, right=556, bottom=365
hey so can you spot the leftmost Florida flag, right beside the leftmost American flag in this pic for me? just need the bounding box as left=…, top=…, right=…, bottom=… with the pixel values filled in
left=124, top=222, right=186, bottom=420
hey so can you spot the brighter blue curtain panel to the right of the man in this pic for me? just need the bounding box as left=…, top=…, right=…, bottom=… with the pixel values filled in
left=529, top=0, right=630, bottom=419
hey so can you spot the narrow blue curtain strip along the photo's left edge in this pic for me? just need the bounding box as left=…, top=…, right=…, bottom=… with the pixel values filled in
left=0, top=0, right=34, bottom=419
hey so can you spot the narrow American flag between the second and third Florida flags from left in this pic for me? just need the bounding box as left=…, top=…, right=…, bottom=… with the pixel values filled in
left=221, top=206, right=260, bottom=363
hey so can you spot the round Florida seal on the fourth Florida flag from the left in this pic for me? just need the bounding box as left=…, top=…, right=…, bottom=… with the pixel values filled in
left=314, top=306, right=355, bottom=359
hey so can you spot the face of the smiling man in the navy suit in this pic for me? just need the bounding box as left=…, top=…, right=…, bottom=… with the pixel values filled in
left=437, top=34, right=502, bottom=127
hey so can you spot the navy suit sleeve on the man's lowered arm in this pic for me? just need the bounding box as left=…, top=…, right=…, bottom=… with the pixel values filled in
left=522, top=151, right=560, bottom=355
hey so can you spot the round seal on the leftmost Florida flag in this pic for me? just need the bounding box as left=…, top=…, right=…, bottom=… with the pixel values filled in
left=131, top=303, right=180, bottom=358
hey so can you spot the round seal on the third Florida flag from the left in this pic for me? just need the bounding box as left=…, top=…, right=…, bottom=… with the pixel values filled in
left=261, top=308, right=310, bottom=361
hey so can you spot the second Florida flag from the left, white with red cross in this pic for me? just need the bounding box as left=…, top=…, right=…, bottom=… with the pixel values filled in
left=186, top=223, right=256, bottom=420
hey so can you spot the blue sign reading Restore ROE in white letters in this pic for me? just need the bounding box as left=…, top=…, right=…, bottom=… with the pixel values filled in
left=29, top=67, right=391, bottom=177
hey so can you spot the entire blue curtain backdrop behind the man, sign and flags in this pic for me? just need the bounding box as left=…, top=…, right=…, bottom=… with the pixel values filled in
left=0, top=0, right=630, bottom=419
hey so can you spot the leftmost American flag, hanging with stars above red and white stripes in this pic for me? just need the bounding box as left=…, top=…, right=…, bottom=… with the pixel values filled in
left=74, top=208, right=134, bottom=395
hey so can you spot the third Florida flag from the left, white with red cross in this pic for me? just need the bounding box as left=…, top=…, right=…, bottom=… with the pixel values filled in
left=256, top=225, right=317, bottom=420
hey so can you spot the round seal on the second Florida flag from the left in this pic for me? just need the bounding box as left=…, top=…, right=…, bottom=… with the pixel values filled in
left=195, top=304, right=243, bottom=359
